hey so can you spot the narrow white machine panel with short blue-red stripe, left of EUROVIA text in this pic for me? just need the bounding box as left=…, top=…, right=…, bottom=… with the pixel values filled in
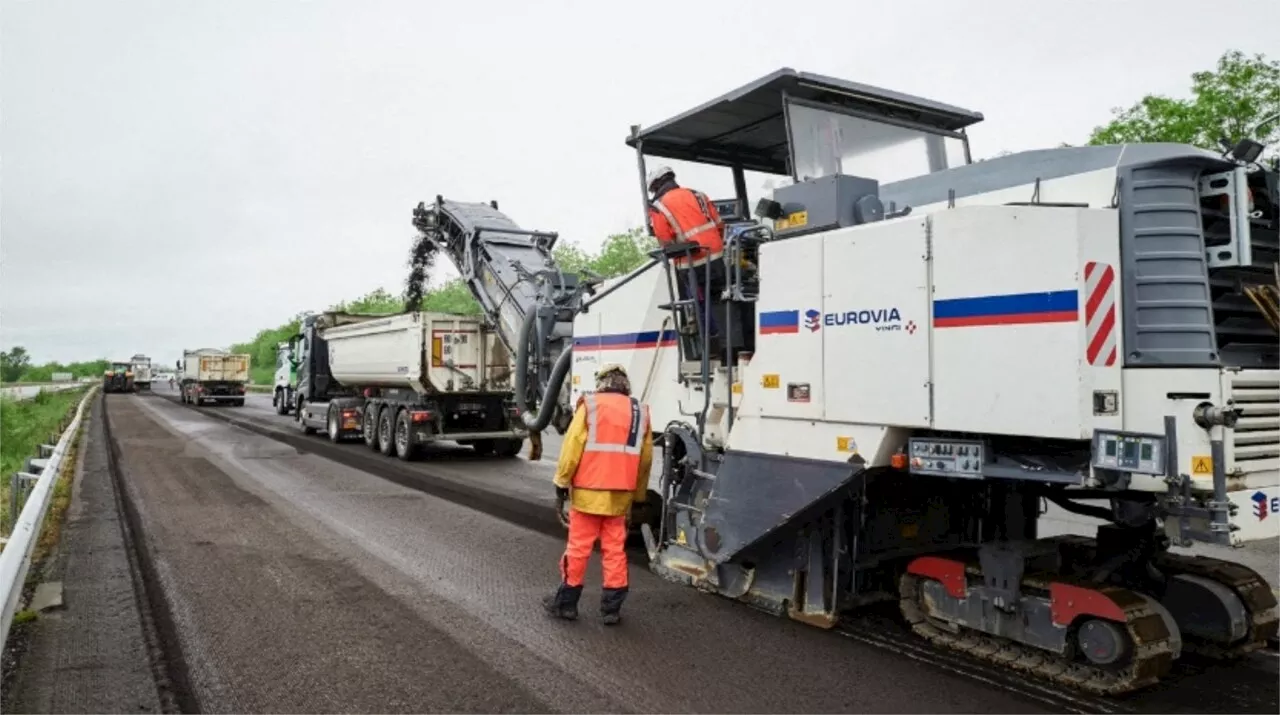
left=741, top=234, right=827, bottom=420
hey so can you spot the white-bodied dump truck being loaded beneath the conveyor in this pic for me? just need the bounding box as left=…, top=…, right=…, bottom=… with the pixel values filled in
left=293, top=312, right=527, bottom=460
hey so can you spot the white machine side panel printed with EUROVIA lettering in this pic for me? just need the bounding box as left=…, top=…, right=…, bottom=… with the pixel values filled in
left=819, top=216, right=932, bottom=427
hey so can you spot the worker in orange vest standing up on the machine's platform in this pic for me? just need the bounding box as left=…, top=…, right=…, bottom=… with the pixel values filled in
left=648, top=166, right=724, bottom=335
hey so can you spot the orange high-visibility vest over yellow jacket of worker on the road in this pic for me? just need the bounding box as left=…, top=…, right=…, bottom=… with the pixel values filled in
left=573, top=393, right=649, bottom=492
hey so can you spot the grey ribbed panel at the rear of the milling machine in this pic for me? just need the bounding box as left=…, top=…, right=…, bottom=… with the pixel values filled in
left=1120, top=164, right=1220, bottom=367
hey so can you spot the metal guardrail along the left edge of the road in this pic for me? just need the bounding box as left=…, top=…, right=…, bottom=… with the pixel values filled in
left=0, top=385, right=97, bottom=648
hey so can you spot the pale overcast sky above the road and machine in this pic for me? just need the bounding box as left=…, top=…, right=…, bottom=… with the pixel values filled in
left=0, top=0, right=1280, bottom=365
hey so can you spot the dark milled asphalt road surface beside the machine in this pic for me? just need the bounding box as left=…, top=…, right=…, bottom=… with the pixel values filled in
left=106, top=388, right=1277, bottom=712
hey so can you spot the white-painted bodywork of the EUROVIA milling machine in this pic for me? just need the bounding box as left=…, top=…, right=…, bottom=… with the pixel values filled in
left=572, top=199, right=1280, bottom=542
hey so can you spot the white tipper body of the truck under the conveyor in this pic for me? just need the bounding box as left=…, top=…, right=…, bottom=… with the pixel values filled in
left=321, top=312, right=512, bottom=394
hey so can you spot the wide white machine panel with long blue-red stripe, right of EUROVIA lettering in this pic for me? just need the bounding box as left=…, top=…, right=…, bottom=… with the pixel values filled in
left=932, top=206, right=1091, bottom=439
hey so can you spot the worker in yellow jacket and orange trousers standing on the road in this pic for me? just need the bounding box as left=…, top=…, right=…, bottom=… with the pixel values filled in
left=543, top=365, right=653, bottom=625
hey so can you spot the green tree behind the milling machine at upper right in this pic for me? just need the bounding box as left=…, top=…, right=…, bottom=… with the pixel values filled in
left=1089, top=51, right=1280, bottom=151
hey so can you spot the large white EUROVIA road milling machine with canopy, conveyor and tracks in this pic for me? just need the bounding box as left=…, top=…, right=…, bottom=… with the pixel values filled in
left=415, top=69, right=1280, bottom=695
